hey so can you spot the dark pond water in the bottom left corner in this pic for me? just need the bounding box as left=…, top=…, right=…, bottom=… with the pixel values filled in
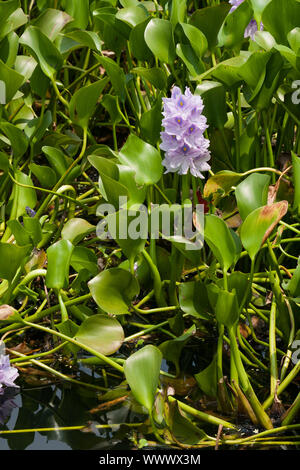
left=0, top=367, right=145, bottom=450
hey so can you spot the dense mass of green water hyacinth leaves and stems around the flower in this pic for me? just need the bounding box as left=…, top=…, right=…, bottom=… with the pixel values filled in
left=0, top=0, right=300, bottom=446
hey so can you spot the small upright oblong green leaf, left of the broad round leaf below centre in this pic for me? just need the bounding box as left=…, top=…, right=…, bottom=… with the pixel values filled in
left=46, top=240, right=74, bottom=289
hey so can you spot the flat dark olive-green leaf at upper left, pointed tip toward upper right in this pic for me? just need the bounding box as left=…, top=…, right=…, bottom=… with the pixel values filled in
left=70, top=78, right=108, bottom=128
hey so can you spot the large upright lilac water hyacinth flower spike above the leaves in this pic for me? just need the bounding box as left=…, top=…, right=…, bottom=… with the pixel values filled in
left=160, top=86, right=210, bottom=178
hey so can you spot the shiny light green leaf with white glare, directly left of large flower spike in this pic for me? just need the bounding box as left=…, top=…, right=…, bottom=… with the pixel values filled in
left=119, top=134, right=163, bottom=185
